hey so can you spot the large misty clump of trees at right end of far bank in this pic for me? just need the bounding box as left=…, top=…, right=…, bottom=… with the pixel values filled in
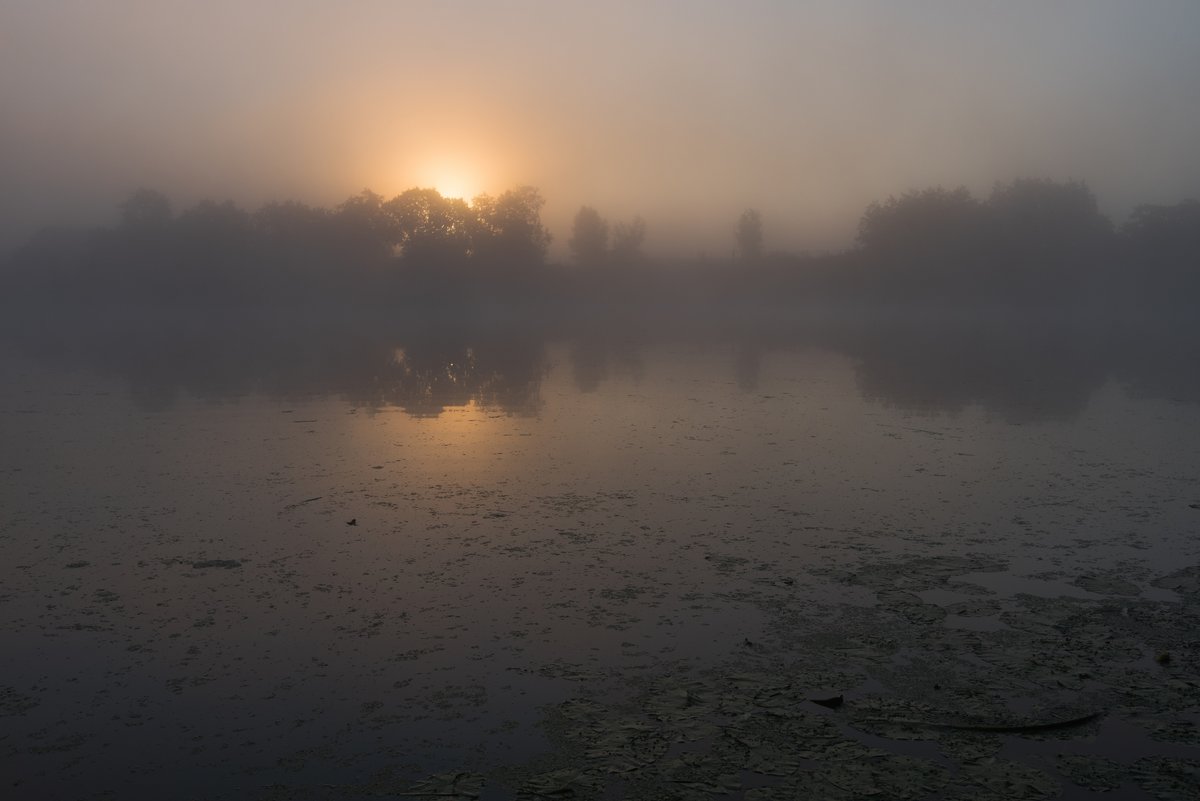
left=840, top=179, right=1200, bottom=303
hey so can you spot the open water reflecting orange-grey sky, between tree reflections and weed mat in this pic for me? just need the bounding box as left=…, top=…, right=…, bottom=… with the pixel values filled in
left=0, top=330, right=1200, bottom=797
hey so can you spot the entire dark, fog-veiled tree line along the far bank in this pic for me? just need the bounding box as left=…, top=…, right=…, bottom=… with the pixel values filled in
left=4, top=179, right=1200, bottom=305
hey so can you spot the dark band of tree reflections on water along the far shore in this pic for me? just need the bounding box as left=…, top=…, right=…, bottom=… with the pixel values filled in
left=4, top=309, right=1200, bottom=422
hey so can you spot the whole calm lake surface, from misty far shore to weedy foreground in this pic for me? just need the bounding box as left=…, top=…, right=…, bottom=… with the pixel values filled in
left=0, top=320, right=1200, bottom=801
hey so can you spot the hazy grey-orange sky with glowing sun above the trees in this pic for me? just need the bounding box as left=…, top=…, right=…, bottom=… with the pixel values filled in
left=0, top=0, right=1200, bottom=254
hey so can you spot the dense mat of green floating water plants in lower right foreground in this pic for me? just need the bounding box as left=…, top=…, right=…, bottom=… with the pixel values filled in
left=400, top=558, right=1200, bottom=801
